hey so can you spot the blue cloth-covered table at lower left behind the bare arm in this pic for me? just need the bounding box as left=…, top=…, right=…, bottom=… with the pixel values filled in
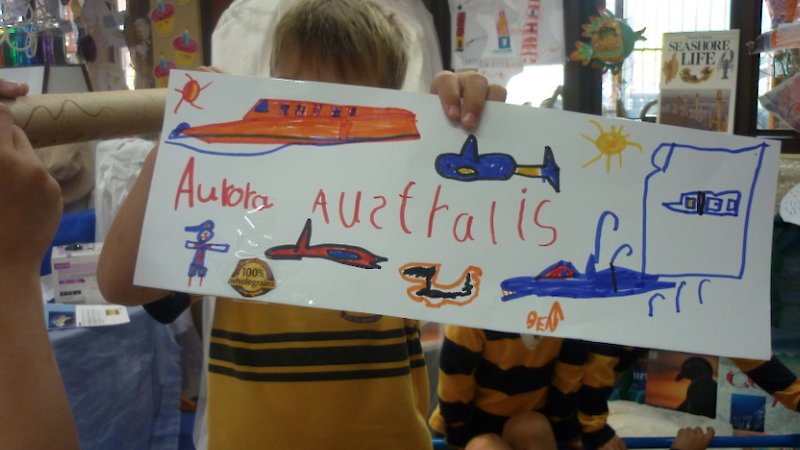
left=49, top=307, right=181, bottom=450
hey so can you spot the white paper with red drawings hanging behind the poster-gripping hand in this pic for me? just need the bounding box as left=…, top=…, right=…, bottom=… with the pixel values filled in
left=450, top=0, right=564, bottom=85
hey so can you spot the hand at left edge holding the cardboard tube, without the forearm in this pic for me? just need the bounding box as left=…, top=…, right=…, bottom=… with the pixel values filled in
left=0, top=103, right=61, bottom=272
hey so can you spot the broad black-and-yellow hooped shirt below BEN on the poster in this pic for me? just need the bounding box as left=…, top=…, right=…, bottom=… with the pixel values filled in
left=429, top=326, right=632, bottom=447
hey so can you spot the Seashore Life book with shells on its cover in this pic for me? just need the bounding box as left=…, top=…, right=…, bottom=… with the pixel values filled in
left=658, top=30, right=739, bottom=133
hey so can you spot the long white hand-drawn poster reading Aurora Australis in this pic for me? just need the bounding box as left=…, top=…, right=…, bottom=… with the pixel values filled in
left=139, top=72, right=779, bottom=358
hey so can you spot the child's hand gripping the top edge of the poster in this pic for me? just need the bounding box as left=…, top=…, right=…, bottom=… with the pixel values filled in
left=431, top=71, right=506, bottom=130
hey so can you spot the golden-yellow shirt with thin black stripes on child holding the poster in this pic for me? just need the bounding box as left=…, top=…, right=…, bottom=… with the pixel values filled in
left=207, top=299, right=432, bottom=450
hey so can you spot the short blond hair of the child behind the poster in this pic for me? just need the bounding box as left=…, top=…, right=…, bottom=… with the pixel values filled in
left=270, top=0, right=408, bottom=89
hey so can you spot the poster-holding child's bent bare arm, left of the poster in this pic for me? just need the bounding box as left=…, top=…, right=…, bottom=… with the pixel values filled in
left=97, top=147, right=170, bottom=306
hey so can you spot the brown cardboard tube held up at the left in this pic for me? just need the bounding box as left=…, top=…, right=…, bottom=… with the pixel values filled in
left=0, top=89, right=167, bottom=148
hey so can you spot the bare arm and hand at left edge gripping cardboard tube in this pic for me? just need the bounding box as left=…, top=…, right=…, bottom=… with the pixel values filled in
left=0, top=96, right=79, bottom=450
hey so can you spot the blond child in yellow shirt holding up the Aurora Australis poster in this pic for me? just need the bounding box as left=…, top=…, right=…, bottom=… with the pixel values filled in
left=98, top=0, right=505, bottom=450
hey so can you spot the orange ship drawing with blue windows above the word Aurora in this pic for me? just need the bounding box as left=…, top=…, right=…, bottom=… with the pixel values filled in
left=169, top=99, right=419, bottom=145
